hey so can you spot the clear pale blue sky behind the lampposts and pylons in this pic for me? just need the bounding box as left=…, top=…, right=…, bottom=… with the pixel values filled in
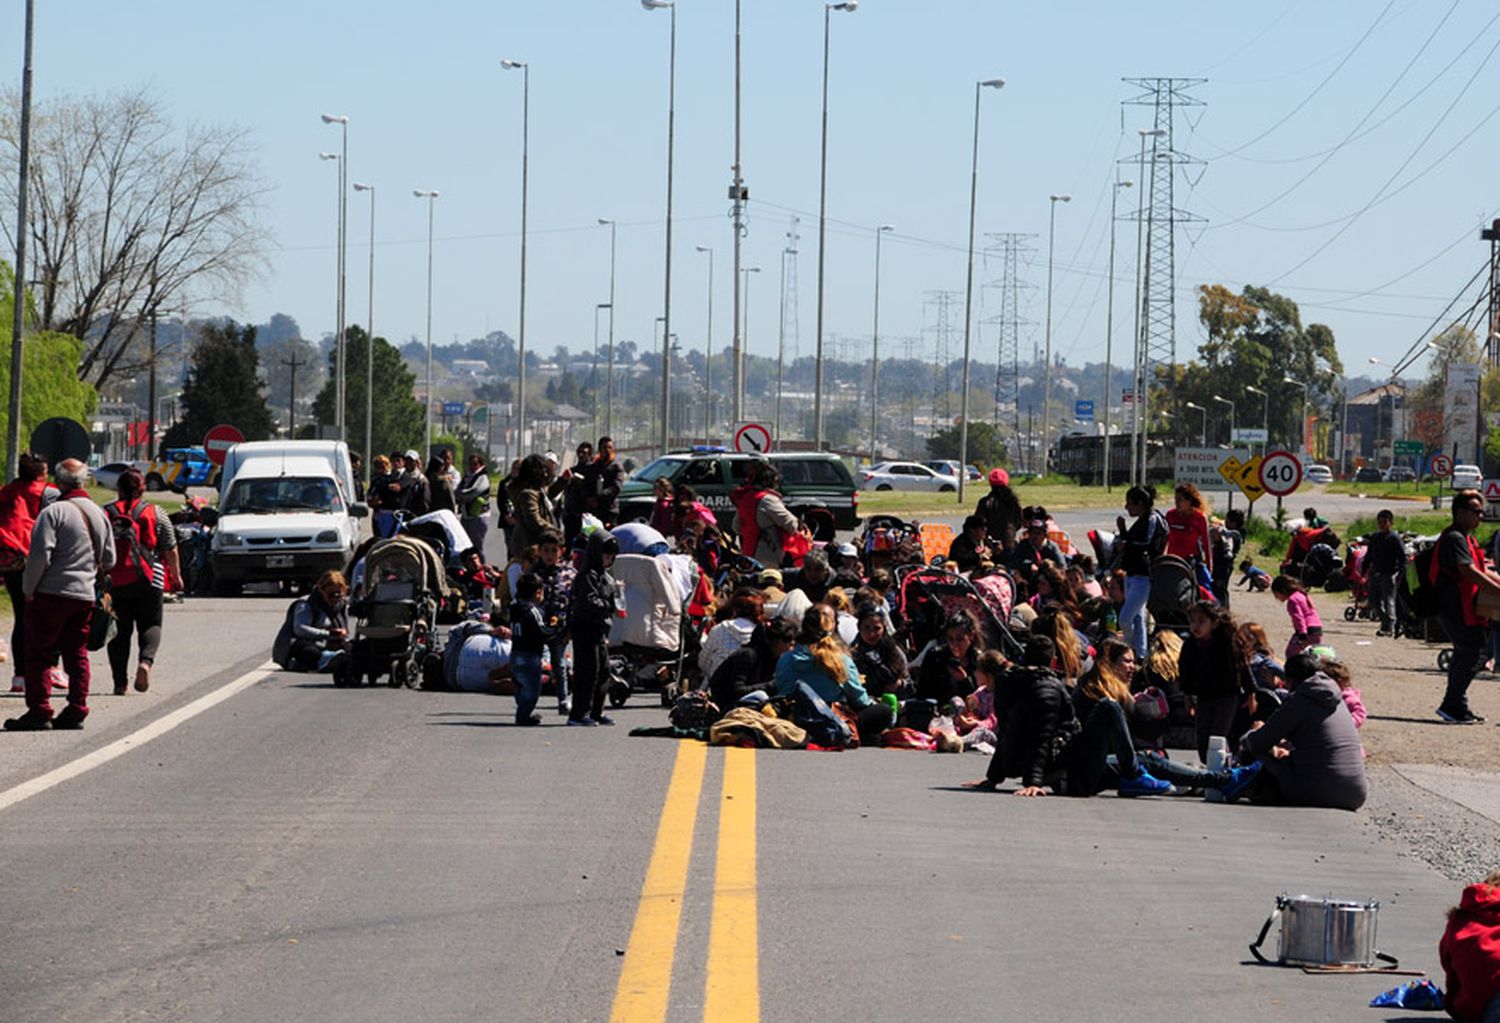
left=20, top=0, right=1500, bottom=372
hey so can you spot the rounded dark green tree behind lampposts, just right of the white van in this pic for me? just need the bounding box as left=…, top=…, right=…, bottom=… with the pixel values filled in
left=312, top=326, right=428, bottom=452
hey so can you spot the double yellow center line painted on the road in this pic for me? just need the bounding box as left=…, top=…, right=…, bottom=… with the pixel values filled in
left=611, top=743, right=761, bottom=1023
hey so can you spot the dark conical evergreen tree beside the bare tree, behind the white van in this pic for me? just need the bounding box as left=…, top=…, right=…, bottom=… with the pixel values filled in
left=162, top=323, right=276, bottom=447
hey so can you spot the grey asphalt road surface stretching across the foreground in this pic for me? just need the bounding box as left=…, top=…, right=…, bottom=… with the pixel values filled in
left=0, top=579, right=1457, bottom=1023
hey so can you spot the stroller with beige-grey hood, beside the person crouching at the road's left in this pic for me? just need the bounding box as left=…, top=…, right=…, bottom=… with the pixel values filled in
left=347, top=536, right=446, bottom=689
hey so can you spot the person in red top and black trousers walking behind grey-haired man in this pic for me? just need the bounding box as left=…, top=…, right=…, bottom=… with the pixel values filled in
left=104, top=470, right=182, bottom=696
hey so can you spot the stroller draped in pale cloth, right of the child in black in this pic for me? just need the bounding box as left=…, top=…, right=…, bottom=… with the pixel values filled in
left=609, top=554, right=698, bottom=707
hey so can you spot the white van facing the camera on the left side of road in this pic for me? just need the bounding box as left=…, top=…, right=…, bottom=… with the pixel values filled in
left=210, top=444, right=368, bottom=596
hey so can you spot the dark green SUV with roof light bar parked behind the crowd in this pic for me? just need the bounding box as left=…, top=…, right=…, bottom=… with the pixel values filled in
left=620, top=450, right=860, bottom=540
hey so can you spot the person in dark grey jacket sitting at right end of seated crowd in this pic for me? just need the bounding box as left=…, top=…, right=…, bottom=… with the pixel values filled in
left=1239, top=654, right=1370, bottom=810
